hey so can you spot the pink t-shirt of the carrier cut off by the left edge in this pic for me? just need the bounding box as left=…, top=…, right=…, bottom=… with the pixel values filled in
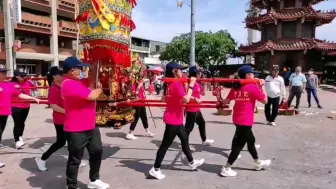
left=0, top=82, right=21, bottom=116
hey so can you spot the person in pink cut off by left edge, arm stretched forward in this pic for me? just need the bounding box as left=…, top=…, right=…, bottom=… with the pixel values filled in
left=0, top=65, right=39, bottom=167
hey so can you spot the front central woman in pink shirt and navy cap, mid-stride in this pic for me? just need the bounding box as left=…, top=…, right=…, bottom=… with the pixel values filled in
left=149, top=62, right=204, bottom=179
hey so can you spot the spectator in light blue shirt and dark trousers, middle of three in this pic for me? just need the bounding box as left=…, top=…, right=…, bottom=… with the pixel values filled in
left=288, top=66, right=307, bottom=109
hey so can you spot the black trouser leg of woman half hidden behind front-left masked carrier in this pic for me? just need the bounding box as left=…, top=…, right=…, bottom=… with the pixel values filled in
left=41, top=124, right=66, bottom=161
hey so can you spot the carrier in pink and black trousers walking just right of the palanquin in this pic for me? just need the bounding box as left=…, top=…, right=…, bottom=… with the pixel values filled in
left=126, top=81, right=154, bottom=140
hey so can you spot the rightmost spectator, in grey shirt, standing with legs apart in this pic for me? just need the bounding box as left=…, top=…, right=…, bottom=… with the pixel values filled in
left=306, top=68, right=322, bottom=108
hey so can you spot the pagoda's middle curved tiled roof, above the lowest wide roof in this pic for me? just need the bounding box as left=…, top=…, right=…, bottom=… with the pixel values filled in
left=245, top=7, right=336, bottom=29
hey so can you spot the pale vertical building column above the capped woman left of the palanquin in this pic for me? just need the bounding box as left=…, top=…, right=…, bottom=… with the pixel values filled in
left=50, top=0, right=59, bottom=66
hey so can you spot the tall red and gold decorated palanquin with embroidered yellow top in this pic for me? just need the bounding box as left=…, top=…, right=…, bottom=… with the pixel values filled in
left=76, top=0, right=140, bottom=128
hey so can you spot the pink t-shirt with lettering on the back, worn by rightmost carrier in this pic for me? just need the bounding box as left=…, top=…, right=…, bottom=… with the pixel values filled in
left=227, top=84, right=265, bottom=126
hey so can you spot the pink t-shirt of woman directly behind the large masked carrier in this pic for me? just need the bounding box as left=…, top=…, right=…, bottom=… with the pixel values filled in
left=48, top=84, right=64, bottom=125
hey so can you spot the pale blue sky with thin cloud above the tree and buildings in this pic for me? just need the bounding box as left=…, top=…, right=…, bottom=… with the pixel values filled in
left=132, top=0, right=336, bottom=43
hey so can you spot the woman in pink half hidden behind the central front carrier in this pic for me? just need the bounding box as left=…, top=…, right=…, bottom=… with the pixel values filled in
left=185, top=66, right=214, bottom=146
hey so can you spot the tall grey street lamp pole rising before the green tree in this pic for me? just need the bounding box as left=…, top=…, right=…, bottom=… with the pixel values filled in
left=177, top=0, right=196, bottom=67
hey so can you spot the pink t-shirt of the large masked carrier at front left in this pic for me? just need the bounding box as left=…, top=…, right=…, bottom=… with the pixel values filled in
left=61, top=78, right=96, bottom=132
